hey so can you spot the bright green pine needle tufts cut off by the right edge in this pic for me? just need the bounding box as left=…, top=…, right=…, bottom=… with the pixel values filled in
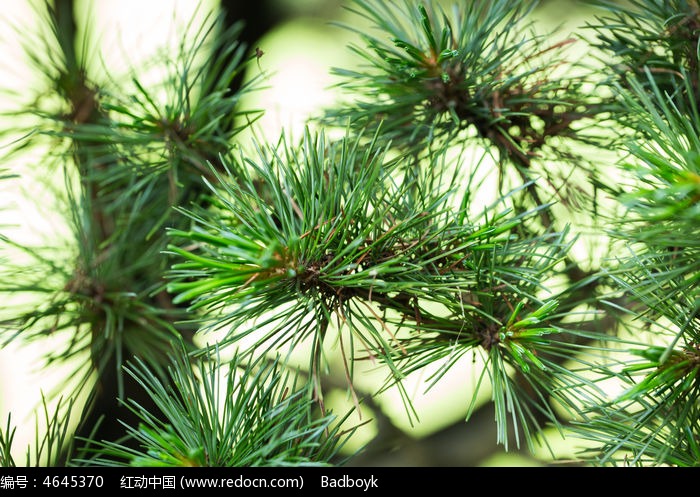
left=568, top=1, right=700, bottom=466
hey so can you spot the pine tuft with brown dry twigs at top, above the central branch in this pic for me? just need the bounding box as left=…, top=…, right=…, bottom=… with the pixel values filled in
left=322, top=0, right=609, bottom=224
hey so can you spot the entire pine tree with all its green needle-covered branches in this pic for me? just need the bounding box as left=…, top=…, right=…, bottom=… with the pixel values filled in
left=0, top=0, right=700, bottom=467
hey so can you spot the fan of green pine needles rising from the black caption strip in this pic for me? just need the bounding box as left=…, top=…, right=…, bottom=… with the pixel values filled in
left=74, top=340, right=354, bottom=467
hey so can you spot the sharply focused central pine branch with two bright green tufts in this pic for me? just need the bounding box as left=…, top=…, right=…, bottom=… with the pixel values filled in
left=168, top=126, right=608, bottom=452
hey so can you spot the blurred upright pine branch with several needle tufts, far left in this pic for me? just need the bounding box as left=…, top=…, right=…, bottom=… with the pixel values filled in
left=3, top=2, right=266, bottom=462
